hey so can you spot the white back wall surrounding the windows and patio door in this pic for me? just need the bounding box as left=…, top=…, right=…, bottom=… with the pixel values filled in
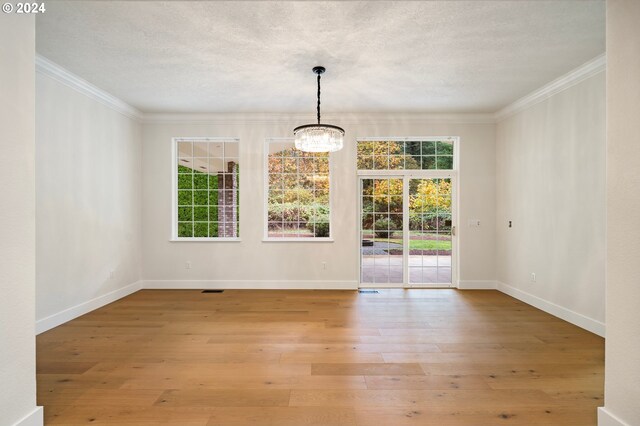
left=142, top=116, right=495, bottom=288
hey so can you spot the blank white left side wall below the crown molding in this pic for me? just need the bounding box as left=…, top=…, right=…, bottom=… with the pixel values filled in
left=36, top=72, right=142, bottom=330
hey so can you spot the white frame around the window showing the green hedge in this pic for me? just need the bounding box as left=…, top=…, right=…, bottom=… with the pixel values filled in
left=169, top=136, right=242, bottom=243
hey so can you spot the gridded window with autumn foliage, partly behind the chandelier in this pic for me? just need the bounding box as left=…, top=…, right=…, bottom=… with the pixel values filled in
left=265, top=139, right=331, bottom=241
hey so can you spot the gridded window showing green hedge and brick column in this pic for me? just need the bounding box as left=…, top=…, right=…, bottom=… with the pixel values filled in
left=172, top=138, right=240, bottom=241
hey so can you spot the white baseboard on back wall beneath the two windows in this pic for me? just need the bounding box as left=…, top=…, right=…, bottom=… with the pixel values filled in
left=142, top=280, right=358, bottom=290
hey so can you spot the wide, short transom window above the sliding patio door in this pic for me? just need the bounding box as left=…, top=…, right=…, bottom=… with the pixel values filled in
left=358, top=139, right=454, bottom=170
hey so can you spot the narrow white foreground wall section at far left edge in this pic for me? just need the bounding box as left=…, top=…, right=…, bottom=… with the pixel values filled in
left=0, top=13, right=42, bottom=425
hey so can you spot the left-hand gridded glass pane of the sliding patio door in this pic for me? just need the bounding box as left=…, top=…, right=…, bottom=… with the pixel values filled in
left=360, top=178, right=404, bottom=286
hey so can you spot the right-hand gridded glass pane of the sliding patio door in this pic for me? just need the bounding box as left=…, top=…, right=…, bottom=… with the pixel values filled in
left=408, top=178, right=452, bottom=285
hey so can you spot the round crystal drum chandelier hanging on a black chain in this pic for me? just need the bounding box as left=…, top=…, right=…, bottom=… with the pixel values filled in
left=293, top=67, right=344, bottom=152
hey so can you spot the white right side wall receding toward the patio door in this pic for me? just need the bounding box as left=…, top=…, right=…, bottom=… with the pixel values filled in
left=496, top=71, right=605, bottom=334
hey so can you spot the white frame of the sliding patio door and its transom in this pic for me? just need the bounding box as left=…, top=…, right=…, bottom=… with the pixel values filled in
left=355, top=136, right=462, bottom=288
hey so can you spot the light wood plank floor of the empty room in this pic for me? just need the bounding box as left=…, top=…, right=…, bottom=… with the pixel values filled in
left=37, top=290, right=604, bottom=426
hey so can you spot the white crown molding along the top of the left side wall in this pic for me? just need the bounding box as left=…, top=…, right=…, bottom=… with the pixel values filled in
left=36, top=54, right=143, bottom=121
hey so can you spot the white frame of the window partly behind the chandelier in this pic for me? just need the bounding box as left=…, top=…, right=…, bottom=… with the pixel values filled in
left=262, top=137, right=334, bottom=243
